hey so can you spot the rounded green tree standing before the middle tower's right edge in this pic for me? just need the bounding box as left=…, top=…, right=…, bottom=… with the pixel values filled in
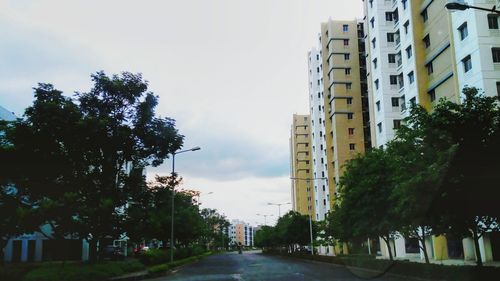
left=334, top=149, right=401, bottom=260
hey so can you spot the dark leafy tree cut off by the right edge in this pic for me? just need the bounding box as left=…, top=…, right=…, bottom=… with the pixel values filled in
left=402, top=88, right=500, bottom=265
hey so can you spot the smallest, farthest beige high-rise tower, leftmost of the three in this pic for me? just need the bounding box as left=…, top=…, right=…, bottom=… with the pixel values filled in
left=290, top=114, right=314, bottom=217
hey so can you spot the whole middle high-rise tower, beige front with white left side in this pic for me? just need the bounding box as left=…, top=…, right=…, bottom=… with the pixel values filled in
left=308, top=20, right=370, bottom=220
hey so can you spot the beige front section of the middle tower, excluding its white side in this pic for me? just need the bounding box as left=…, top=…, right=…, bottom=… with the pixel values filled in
left=320, top=20, right=371, bottom=210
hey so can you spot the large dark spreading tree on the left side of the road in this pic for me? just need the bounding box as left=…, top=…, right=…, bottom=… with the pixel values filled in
left=0, top=72, right=183, bottom=260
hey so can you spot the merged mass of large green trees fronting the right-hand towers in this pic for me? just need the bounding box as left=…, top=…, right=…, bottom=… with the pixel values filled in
left=325, top=88, right=500, bottom=265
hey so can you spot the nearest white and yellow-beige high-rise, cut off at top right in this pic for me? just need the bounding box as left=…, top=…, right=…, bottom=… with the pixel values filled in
left=363, top=0, right=500, bottom=260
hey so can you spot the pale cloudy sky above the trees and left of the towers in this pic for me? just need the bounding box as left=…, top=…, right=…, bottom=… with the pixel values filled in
left=0, top=0, right=362, bottom=225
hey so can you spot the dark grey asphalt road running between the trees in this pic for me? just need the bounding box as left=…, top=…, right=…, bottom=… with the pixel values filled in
left=151, top=249, right=412, bottom=281
